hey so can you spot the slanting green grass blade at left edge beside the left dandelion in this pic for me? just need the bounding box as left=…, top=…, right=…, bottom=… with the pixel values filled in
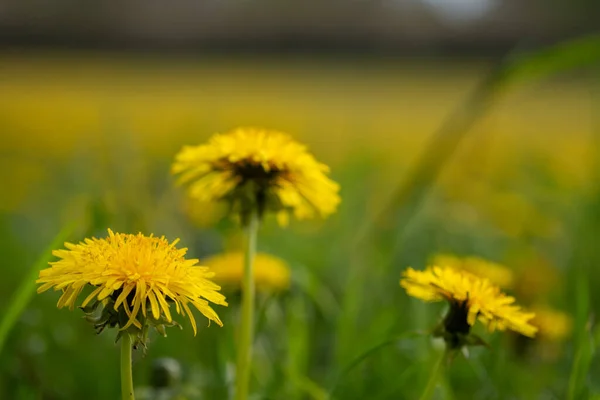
left=0, top=224, right=74, bottom=353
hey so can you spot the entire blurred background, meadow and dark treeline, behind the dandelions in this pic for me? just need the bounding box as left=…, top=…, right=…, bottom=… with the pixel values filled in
left=0, top=0, right=600, bottom=400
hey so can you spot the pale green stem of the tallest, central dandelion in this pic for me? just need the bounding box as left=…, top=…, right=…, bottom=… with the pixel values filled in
left=235, top=211, right=259, bottom=400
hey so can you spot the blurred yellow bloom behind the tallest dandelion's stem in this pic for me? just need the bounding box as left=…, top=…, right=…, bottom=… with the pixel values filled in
left=203, top=252, right=291, bottom=291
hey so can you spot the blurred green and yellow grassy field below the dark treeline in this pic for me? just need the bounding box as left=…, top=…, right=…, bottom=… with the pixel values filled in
left=0, top=52, right=600, bottom=400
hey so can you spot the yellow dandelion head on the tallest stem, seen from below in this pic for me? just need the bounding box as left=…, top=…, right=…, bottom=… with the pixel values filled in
left=171, top=128, right=340, bottom=224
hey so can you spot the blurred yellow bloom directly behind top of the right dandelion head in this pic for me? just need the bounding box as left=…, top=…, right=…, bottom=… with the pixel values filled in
left=431, top=254, right=515, bottom=289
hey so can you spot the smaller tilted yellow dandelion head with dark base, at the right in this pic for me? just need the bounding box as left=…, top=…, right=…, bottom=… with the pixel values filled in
left=400, top=266, right=537, bottom=348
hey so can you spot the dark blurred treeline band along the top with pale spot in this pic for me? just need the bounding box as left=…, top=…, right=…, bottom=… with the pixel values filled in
left=0, top=0, right=600, bottom=54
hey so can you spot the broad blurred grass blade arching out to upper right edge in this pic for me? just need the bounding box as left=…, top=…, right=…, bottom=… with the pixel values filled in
left=357, top=35, right=600, bottom=247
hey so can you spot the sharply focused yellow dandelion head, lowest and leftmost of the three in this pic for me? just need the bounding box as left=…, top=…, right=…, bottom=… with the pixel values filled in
left=37, top=229, right=227, bottom=340
